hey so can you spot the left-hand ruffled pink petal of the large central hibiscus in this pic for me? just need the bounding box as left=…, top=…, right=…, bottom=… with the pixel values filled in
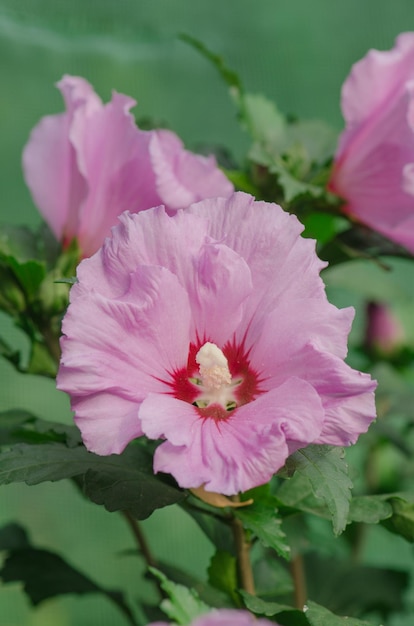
left=57, top=267, right=190, bottom=454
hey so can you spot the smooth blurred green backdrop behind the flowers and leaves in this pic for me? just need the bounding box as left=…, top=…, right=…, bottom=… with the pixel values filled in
left=0, top=0, right=414, bottom=626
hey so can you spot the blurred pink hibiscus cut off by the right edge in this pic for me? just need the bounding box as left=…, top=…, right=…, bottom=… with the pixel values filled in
left=329, top=33, right=414, bottom=253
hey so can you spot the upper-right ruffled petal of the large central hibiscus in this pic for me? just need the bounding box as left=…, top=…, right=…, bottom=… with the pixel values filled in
left=187, top=192, right=326, bottom=339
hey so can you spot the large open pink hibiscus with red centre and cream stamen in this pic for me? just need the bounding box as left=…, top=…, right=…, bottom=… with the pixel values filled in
left=58, top=193, right=375, bottom=495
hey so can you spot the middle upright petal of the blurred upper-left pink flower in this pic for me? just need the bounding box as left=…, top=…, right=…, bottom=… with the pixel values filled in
left=71, top=93, right=160, bottom=255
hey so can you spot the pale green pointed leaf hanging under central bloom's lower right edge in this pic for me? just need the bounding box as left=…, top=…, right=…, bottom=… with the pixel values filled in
left=286, top=445, right=352, bottom=535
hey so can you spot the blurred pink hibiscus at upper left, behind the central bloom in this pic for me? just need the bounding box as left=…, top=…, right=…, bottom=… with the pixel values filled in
left=23, top=76, right=233, bottom=256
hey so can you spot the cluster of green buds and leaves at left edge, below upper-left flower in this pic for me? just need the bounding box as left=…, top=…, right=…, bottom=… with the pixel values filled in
left=0, top=225, right=80, bottom=378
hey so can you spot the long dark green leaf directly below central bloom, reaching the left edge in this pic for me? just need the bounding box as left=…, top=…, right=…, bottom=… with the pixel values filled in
left=0, top=443, right=185, bottom=519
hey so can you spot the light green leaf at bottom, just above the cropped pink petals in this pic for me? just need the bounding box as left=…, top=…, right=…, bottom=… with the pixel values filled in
left=149, top=567, right=210, bottom=625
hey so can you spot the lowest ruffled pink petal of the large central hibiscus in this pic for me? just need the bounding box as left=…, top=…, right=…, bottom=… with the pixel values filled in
left=147, top=379, right=323, bottom=495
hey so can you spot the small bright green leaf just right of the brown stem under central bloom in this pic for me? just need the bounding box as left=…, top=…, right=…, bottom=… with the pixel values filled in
left=234, top=486, right=290, bottom=559
